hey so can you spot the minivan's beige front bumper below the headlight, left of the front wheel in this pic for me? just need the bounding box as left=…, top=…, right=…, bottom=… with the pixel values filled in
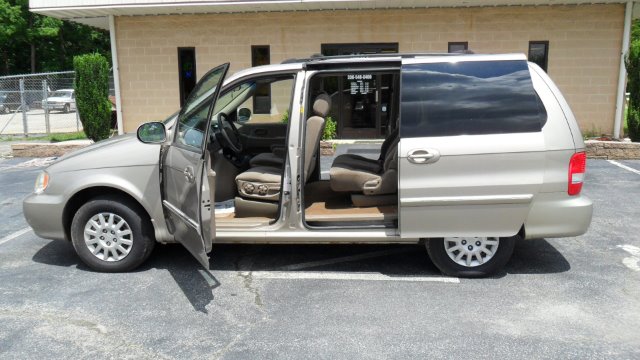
left=22, top=193, right=65, bottom=240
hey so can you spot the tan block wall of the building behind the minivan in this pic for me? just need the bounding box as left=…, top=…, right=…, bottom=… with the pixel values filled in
left=116, top=4, right=624, bottom=133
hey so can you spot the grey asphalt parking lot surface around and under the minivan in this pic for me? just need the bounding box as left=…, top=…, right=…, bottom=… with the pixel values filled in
left=0, top=159, right=640, bottom=359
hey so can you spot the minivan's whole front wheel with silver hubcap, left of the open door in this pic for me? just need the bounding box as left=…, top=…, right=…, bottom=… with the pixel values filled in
left=71, top=197, right=155, bottom=272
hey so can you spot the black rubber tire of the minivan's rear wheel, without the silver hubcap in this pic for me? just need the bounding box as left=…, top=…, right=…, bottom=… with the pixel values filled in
left=425, top=235, right=520, bottom=278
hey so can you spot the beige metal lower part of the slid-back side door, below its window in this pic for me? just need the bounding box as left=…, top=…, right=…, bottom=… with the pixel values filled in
left=399, top=132, right=545, bottom=238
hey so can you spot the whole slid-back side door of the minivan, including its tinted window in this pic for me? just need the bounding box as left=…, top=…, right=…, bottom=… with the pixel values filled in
left=399, top=55, right=545, bottom=238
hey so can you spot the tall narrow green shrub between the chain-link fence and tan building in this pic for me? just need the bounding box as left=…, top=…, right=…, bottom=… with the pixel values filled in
left=73, top=53, right=111, bottom=141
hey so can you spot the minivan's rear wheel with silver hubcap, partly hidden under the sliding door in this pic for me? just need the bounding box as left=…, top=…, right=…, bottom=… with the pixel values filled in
left=426, top=235, right=520, bottom=277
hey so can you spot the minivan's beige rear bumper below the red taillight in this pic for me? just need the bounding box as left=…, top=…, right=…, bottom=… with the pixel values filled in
left=524, top=193, right=593, bottom=239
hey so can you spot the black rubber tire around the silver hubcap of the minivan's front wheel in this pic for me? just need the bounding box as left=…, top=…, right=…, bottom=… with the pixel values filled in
left=71, top=196, right=156, bottom=272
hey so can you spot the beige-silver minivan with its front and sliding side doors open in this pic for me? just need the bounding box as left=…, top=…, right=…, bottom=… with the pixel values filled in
left=24, top=54, right=592, bottom=277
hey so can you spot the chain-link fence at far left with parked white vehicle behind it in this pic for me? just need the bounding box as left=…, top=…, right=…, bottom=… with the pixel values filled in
left=0, top=71, right=114, bottom=136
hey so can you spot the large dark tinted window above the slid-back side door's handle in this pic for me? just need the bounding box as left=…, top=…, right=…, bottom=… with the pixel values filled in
left=400, top=60, right=546, bottom=137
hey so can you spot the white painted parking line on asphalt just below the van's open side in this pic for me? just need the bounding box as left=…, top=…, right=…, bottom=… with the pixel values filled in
left=250, top=271, right=460, bottom=284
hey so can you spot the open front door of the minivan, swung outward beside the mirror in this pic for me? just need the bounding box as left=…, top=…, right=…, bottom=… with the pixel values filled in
left=160, top=63, right=229, bottom=269
